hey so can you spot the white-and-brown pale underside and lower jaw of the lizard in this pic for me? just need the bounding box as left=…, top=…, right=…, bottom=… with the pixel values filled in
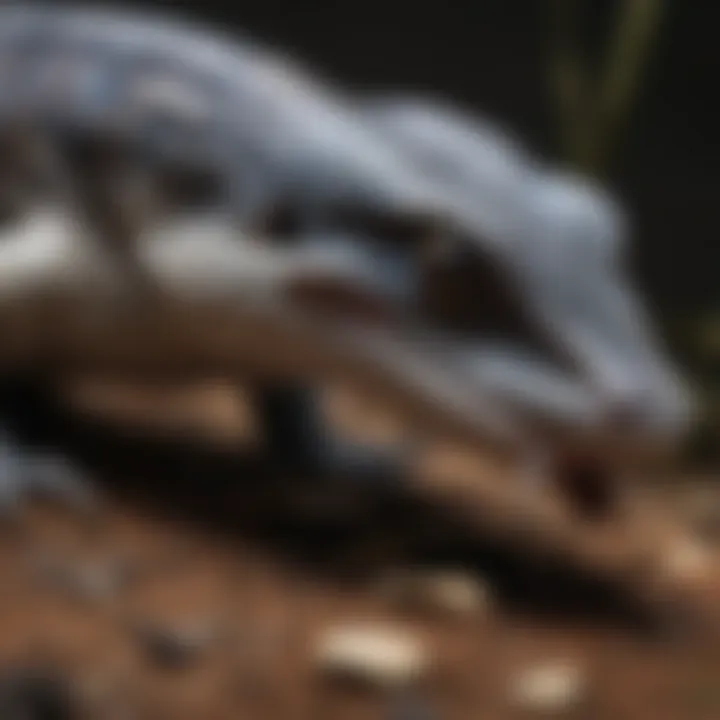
left=0, top=208, right=520, bottom=506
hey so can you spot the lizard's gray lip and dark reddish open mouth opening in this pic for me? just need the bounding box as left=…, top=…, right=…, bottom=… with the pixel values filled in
left=444, top=344, right=688, bottom=522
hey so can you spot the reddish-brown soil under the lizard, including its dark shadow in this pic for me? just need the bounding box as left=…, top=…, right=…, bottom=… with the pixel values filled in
left=0, top=380, right=720, bottom=720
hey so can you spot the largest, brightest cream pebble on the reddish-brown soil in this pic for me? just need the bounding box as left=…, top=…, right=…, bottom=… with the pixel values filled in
left=315, top=623, right=430, bottom=688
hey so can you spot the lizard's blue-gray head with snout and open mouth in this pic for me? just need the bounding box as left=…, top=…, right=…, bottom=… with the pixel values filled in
left=359, top=94, right=694, bottom=516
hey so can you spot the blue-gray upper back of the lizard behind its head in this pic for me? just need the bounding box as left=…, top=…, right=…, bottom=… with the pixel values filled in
left=0, top=6, right=450, bottom=240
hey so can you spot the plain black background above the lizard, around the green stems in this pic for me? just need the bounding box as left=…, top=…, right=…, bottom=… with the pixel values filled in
left=136, top=0, right=720, bottom=320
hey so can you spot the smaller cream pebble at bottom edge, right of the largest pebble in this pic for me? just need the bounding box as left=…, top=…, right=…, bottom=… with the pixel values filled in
left=510, top=662, right=586, bottom=715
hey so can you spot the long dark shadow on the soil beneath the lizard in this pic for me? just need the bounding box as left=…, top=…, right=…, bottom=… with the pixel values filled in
left=21, top=386, right=668, bottom=635
